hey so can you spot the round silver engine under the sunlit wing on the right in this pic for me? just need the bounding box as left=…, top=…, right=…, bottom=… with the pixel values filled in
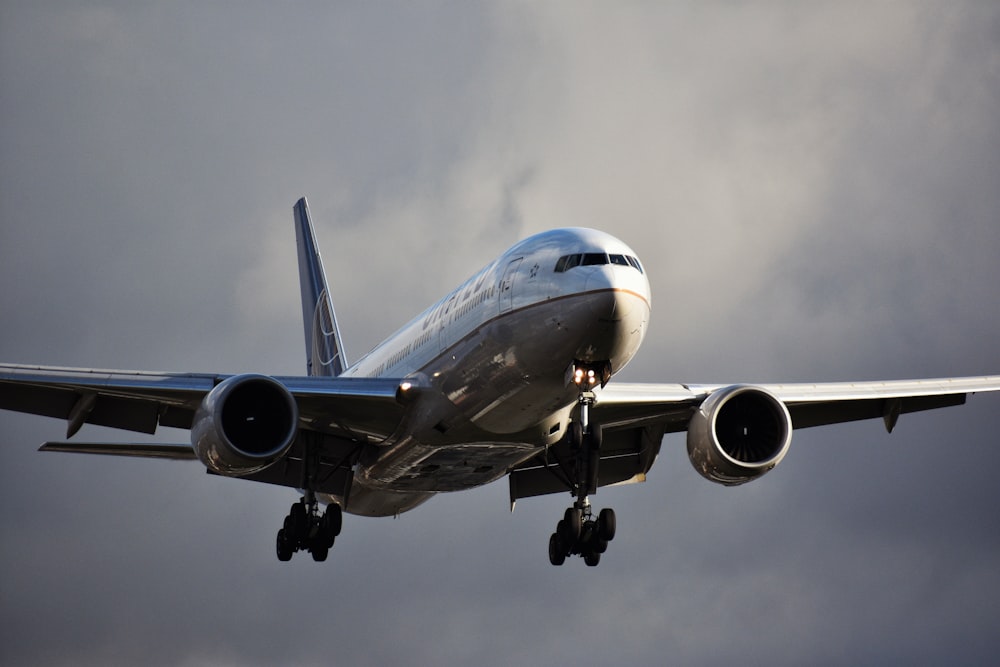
left=687, top=385, right=792, bottom=486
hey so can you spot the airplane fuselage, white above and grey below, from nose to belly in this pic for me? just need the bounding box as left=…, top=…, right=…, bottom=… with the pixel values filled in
left=325, top=229, right=650, bottom=516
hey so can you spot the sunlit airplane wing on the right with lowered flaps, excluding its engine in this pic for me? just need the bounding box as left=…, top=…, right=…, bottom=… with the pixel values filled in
left=510, top=375, right=1000, bottom=504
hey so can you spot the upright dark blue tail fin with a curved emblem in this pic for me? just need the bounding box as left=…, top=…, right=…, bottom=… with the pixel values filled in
left=293, top=197, right=347, bottom=376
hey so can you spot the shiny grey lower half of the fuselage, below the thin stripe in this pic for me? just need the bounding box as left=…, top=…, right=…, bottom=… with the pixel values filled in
left=349, top=292, right=648, bottom=511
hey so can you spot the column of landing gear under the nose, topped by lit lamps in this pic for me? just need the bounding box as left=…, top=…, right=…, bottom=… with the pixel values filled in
left=549, top=366, right=617, bottom=567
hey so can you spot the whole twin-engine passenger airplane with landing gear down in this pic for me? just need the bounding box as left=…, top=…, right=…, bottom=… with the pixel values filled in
left=0, top=198, right=1000, bottom=566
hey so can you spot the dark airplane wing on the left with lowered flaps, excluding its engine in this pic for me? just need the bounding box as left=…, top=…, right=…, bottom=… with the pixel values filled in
left=0, top=364, right=412, bottom=494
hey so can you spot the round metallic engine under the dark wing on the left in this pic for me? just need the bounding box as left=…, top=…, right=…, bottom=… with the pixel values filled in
left=191, top=375, right=299, bottom=475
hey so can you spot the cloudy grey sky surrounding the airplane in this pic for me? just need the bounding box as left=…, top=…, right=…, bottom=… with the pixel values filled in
left=0, top=0, right=1000, bottom=666
